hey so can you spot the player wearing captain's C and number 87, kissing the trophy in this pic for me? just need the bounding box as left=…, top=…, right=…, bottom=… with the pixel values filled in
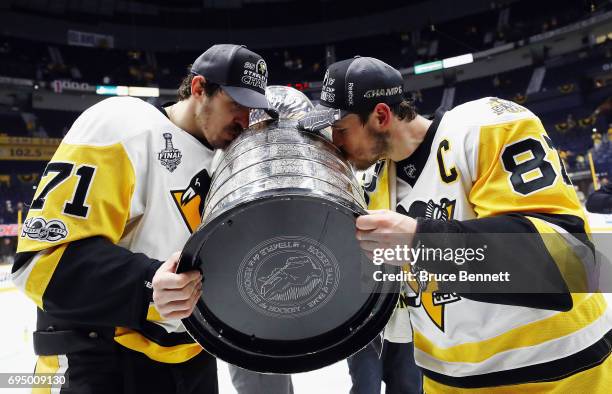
left=300, top=57, right=612, bottom=393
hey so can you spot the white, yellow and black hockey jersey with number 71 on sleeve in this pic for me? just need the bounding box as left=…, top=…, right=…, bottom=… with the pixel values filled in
left=13, top=97, right=214, bottom=363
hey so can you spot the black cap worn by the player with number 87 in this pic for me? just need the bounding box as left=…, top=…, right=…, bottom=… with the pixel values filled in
left=299, top=56, right=404, bottom=131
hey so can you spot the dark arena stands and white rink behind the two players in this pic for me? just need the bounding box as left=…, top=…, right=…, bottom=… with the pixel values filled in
left=0, top=0, right=612, bottom=393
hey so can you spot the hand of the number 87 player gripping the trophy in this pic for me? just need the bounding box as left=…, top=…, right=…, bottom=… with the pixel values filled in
left=356, top=210, right=417, bottom=265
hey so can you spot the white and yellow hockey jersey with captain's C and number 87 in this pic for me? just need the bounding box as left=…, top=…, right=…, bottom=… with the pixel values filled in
left=366, top=97, right=612, bottom=393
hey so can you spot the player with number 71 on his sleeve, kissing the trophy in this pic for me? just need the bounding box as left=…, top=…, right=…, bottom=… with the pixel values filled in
left=13, top=44, right=268, bottom=394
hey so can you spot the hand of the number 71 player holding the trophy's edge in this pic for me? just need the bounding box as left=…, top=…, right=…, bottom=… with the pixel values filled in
left=153, top=252, right=202, bottom=319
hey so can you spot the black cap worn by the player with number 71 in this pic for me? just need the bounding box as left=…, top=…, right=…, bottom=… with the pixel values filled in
left=191, top=44, right=268, bottom=108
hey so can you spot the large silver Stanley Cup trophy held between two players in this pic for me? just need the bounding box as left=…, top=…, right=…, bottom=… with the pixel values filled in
left=178, top=86, right=399, bottom=373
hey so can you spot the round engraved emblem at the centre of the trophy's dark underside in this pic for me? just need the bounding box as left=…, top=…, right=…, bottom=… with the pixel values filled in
left=237, top=237, right=340, bottom=318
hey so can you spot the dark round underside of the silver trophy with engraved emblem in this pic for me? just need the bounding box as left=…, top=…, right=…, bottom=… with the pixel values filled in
left=181, top=194, right=398, bottom=373
